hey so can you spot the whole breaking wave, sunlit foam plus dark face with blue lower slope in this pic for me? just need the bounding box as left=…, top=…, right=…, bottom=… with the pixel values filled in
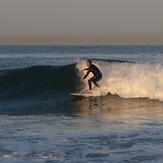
left=0, top=59, right=163, bottom=114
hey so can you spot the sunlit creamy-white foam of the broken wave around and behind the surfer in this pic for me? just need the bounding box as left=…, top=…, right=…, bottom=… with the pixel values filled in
left=77, top=60, right=163, bottom=101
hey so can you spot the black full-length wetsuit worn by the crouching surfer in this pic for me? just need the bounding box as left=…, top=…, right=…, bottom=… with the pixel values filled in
left=83, top=64, right=102, bottom=90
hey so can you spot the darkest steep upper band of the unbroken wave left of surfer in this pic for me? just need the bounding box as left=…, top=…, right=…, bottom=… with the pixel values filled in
left=0, top=65, right=76, bottom=97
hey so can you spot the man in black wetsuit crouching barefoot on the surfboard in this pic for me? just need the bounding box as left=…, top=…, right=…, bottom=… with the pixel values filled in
left=81, top=60, right=102, bottom=93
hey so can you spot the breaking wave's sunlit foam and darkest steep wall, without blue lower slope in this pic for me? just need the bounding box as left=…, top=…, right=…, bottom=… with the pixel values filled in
left=0, top=59, right=163, bottom=100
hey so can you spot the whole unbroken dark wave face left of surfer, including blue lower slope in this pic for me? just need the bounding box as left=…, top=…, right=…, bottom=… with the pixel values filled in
left=0, top=64, right=79, bottom=114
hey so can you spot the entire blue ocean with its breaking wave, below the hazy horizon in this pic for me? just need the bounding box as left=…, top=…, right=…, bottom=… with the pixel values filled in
left=0, top=46, right=163, bottom=163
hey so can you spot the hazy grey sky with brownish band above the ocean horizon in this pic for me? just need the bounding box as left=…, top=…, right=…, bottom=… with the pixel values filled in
left=0, top=0, right=163, bottom=44
